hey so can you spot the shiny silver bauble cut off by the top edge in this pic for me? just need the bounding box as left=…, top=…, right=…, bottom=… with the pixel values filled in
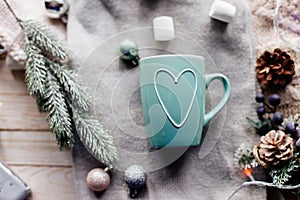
left=45, top=0, right=69, bottom=19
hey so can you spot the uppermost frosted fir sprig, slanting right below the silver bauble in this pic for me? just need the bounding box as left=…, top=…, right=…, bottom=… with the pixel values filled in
left=20, top=20, right=68, bottom=61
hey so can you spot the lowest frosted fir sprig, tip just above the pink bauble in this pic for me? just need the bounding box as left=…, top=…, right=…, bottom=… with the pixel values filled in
left=73, top=108, right=117, bottom=167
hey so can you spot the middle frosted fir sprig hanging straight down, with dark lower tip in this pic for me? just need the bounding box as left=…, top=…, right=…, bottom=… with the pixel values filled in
left=44, top=72, right=74, bottom=149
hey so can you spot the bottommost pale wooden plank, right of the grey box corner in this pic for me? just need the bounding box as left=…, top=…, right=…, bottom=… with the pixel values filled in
left=9, top=166, right=76, bottom=200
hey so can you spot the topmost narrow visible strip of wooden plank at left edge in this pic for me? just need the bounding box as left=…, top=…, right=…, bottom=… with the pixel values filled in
left=0, top=81, right=29, bottom=96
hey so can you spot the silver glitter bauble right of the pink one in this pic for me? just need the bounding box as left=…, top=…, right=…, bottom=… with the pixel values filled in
left=124, top=165, right=147, bottom=198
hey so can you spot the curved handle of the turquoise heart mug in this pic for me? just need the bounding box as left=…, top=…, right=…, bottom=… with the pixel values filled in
left=203, top=73, right=230, bottom=126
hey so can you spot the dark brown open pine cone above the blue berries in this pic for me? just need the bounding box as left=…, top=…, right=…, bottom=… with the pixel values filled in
left=255, top=48, right=295, bottom=87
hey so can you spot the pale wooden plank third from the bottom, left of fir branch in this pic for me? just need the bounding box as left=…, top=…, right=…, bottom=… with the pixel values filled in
left=0, top=95, right=49, bottom=130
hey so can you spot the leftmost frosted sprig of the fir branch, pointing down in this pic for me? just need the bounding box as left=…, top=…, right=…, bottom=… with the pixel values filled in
left=25, top=39, right=47, bottom=97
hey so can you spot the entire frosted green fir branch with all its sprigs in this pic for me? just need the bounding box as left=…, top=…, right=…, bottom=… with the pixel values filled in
left=20, top=20, right=117, bottom=166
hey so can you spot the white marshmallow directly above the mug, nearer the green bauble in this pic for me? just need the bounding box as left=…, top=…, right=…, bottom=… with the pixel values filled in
left=153, top=16, right=175, bottom=41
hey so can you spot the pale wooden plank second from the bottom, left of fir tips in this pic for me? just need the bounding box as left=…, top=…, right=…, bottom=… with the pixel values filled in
left=0, top=131, right=73, bottom=167
